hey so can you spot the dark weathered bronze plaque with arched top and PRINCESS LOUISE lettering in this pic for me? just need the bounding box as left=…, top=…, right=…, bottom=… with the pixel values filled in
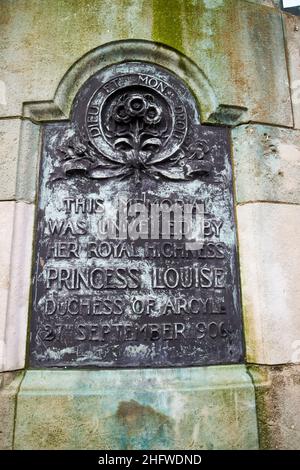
left=30, top=63, right=243, bottom=367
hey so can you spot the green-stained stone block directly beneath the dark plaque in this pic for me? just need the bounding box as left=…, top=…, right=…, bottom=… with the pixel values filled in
left=15, top=365, right=258, bottom=449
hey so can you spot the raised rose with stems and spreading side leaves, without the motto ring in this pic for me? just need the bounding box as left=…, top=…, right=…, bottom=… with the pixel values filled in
left=58, top=92, right=210, bottom=181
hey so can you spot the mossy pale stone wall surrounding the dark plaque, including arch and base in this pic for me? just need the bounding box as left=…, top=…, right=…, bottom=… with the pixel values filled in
left=0, top=0, right=300, bottom=449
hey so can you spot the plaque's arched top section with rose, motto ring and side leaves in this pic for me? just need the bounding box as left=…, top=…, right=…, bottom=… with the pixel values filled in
left=58, top=62, right=210, bottom=182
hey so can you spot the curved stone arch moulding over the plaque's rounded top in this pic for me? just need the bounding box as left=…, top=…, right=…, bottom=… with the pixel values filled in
left=23, top=40, right=219, bottom=122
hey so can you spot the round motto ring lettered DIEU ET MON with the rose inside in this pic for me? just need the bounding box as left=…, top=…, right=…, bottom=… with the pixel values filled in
left=85, top=73, right=187, bottom=166
